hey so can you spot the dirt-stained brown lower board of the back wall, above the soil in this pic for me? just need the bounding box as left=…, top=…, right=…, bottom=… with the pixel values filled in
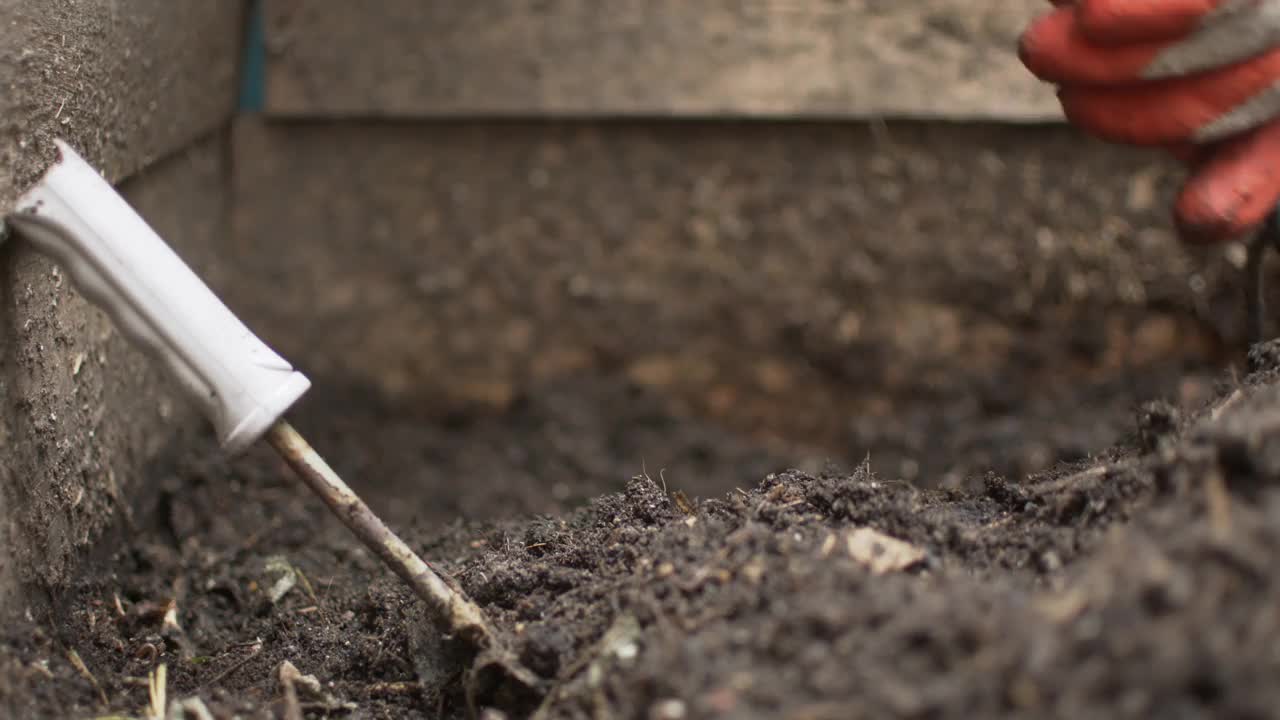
left=225, top=119, right=1242, bottom=476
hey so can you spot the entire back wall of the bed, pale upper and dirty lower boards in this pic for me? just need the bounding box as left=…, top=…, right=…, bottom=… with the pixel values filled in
left=219, top=0, right=1240, bottom=456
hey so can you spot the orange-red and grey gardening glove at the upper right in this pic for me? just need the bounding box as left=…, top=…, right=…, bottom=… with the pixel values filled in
left=1020, top=0, right=1280, bottom=242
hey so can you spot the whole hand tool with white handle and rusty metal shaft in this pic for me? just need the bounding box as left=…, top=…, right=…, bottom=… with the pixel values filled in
left=5, top=141, right=529, bottom=691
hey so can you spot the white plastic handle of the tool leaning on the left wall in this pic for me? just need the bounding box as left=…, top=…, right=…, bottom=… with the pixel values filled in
left=6, top=141, right=311, bottom=454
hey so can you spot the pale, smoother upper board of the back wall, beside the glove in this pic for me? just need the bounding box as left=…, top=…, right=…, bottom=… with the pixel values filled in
left=265, top=0, right=1061, bottom=120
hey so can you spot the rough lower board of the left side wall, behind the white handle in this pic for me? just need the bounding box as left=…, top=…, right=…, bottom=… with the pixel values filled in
left=0, top=133, right=227, bottom=611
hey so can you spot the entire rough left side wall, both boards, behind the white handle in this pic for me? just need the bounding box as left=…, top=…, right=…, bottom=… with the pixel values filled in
left=0, top=0, right=244, bottom=610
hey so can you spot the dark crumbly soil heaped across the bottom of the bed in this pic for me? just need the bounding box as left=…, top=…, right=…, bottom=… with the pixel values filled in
left=0, top=338, right=1280, bottom=720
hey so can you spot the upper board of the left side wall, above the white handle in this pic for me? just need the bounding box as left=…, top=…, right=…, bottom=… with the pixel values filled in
left=0, top=0, right=244, bottom=206
